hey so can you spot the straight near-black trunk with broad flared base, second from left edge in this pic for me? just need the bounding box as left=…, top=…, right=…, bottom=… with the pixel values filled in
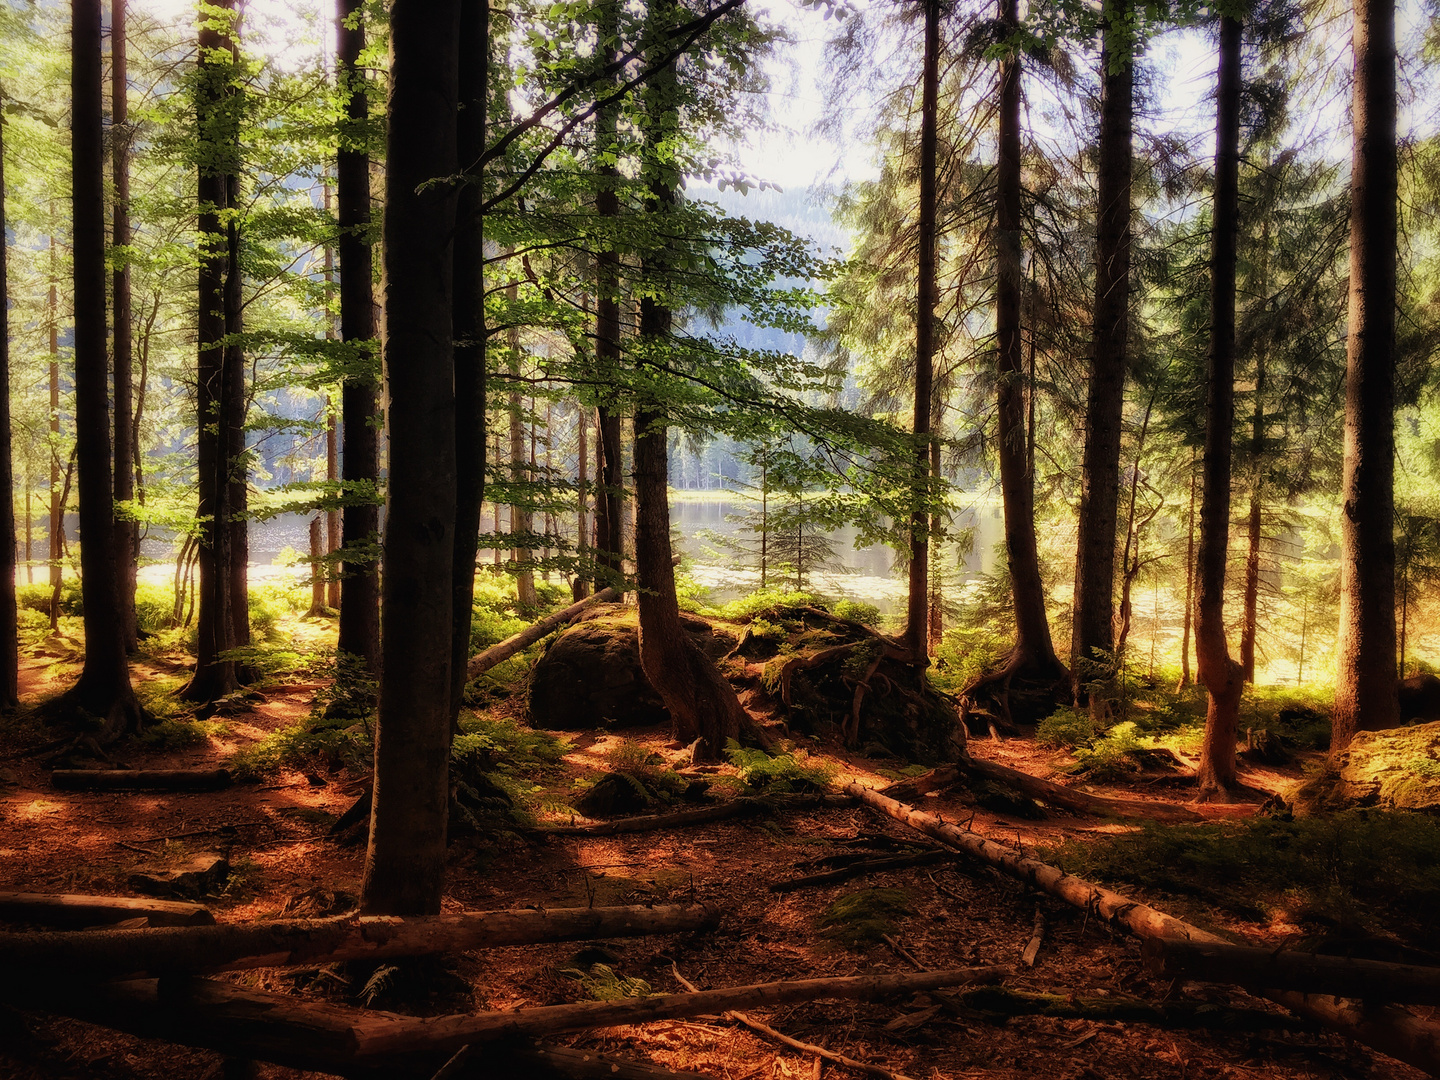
left=55, top=0, right=141, bottom=737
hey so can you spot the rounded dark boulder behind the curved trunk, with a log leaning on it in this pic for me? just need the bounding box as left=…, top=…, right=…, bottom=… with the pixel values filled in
left=530, top=605, right=730, bottom=732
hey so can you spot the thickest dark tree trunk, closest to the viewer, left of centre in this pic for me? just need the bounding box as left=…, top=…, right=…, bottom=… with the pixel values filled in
left=361, top=0, right=461, bottom=914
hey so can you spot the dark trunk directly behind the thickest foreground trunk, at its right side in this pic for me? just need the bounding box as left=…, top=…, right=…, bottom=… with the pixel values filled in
left=451, top=0, right=490, bottom=724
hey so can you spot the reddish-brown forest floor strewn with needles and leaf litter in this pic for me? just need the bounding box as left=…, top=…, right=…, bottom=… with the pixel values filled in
left=0, top=633, right=1421, bottom=1080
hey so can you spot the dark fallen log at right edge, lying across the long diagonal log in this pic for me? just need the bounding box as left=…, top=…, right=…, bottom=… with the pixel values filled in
left=1140, top=939, right=1440, bottom=1005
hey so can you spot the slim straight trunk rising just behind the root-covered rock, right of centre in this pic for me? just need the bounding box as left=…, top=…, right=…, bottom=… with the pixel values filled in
left=904, top=0, right=940, bottom=665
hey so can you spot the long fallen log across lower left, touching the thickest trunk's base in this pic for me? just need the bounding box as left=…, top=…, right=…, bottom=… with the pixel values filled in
left=0, top=904, right=720, bottom=978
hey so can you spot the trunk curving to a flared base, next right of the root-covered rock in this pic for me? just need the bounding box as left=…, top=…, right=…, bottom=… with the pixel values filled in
left=995, top=0, right=1066, bottom=681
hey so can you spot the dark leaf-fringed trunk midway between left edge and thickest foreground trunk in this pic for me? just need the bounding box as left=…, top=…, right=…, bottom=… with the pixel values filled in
left=181, top=0, right=248, bottom=701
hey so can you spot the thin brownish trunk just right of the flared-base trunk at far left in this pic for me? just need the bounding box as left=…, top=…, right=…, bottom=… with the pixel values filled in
left=109, top=0, right=140, bottom=652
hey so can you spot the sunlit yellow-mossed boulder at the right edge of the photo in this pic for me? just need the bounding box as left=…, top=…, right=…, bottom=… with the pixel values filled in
left=1287, top=721, right=1440, bottom=814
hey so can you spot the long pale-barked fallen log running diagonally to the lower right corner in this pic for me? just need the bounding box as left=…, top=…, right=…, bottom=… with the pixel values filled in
left=844, top=783, right=1440, bottom=1076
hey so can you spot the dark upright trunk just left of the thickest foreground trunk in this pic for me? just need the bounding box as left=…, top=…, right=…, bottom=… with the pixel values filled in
left=336, top=0, right=380, bottom=674
